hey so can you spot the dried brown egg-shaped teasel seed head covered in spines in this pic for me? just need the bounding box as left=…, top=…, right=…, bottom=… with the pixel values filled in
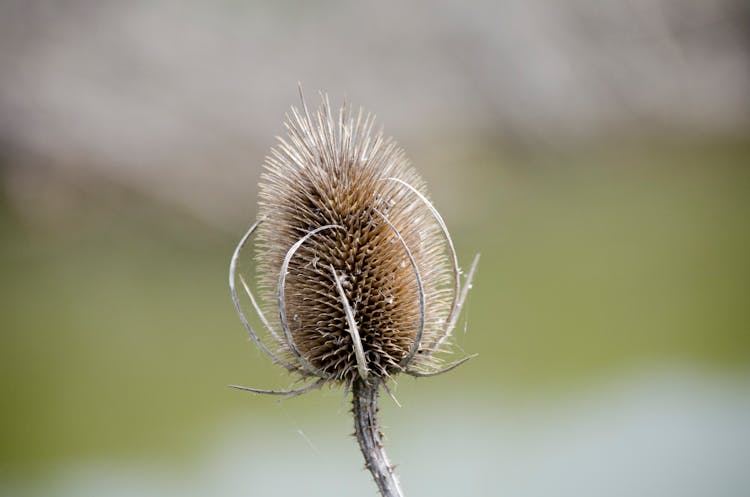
left=232, top=92, right=476, bottom=384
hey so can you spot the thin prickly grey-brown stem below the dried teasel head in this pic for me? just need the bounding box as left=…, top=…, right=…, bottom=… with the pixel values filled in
left=352, top=378, right=403, bottom=497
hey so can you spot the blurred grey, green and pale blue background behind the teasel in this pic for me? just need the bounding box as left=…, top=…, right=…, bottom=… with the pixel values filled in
left=0, top=0, right=750, bottom=497
